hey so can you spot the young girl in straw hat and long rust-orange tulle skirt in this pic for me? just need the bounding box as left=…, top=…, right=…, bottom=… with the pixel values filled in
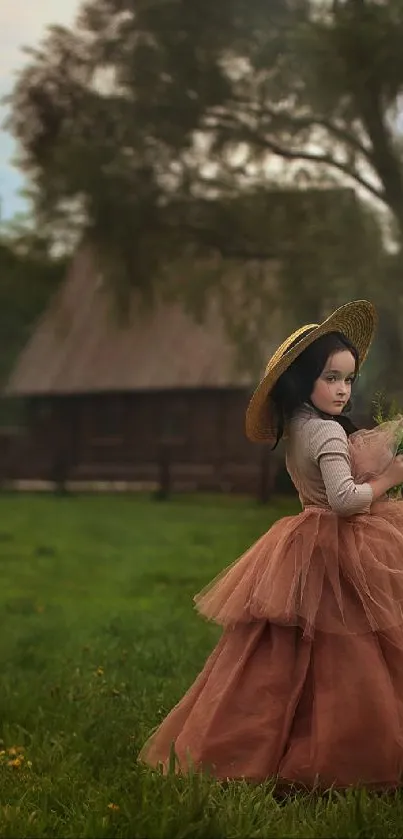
left=140, top=301, right=403, bottom=789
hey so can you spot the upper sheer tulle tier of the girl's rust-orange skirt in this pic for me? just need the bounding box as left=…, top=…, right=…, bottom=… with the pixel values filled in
left=195, top=501, right=403, bottom=638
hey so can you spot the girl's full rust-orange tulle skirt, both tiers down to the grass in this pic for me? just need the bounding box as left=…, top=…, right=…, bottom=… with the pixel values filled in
left=139, top=501, right=403, bottom=789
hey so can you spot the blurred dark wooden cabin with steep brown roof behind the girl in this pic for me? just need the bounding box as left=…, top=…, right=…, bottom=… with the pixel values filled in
left=2, top=248, right=288, bottom=497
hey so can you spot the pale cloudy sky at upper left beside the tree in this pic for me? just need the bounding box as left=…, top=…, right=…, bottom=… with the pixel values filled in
left=0, top=0, right=80, bottom=220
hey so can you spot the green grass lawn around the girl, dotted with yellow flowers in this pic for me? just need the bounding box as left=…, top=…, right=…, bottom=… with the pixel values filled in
left=0, top=496, right=403, bottom=839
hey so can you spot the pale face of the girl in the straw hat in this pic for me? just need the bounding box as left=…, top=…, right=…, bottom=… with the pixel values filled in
left=311, top=350, right=355, bottom=416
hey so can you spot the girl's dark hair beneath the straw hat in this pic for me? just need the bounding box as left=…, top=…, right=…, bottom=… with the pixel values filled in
left=271, top=327, right=359, bottom=449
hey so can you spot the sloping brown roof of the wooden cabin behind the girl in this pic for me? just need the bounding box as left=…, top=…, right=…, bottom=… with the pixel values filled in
left=5, top=248, right=281, bottom=396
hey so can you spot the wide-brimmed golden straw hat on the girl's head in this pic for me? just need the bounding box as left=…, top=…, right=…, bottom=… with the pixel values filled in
left=246, top=300, right=377, bottom=443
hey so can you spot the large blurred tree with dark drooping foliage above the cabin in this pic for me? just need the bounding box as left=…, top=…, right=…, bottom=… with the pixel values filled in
left=4, top=0, right=403, bottom=386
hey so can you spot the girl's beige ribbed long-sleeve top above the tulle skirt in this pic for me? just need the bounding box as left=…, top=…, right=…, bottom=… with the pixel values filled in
left=286, top=405, right=373, bottom=516
